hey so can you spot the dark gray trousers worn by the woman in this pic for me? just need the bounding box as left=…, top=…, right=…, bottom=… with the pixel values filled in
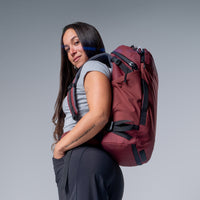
left=53, top=146, right=124, bottom=200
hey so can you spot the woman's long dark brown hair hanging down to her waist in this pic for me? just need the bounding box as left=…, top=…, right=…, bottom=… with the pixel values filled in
left=52, top=22, right=104, bottom=142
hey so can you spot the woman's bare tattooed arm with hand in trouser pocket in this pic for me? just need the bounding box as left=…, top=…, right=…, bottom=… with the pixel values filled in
left=54, top=71, right=111, bottom=159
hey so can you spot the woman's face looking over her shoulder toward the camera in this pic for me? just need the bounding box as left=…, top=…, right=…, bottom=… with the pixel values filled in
left=63, top=28, right=88, bottom=68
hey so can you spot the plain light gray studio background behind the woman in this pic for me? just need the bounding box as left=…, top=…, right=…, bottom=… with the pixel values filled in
left=0, top=0, right=200, bottom=200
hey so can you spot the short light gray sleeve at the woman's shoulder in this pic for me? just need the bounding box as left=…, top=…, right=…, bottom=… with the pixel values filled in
left=78, top=60, right=111, bottom=85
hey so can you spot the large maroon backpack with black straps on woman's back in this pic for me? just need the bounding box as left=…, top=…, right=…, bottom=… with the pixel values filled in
left=68, top=46, right=158, bottom=166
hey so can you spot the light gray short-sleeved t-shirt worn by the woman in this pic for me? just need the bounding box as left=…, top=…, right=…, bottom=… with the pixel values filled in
left=63, top=60, right=111, bottom=133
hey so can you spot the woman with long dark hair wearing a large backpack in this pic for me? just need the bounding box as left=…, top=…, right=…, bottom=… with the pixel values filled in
left=53, top=22, right=123, bottom=200
